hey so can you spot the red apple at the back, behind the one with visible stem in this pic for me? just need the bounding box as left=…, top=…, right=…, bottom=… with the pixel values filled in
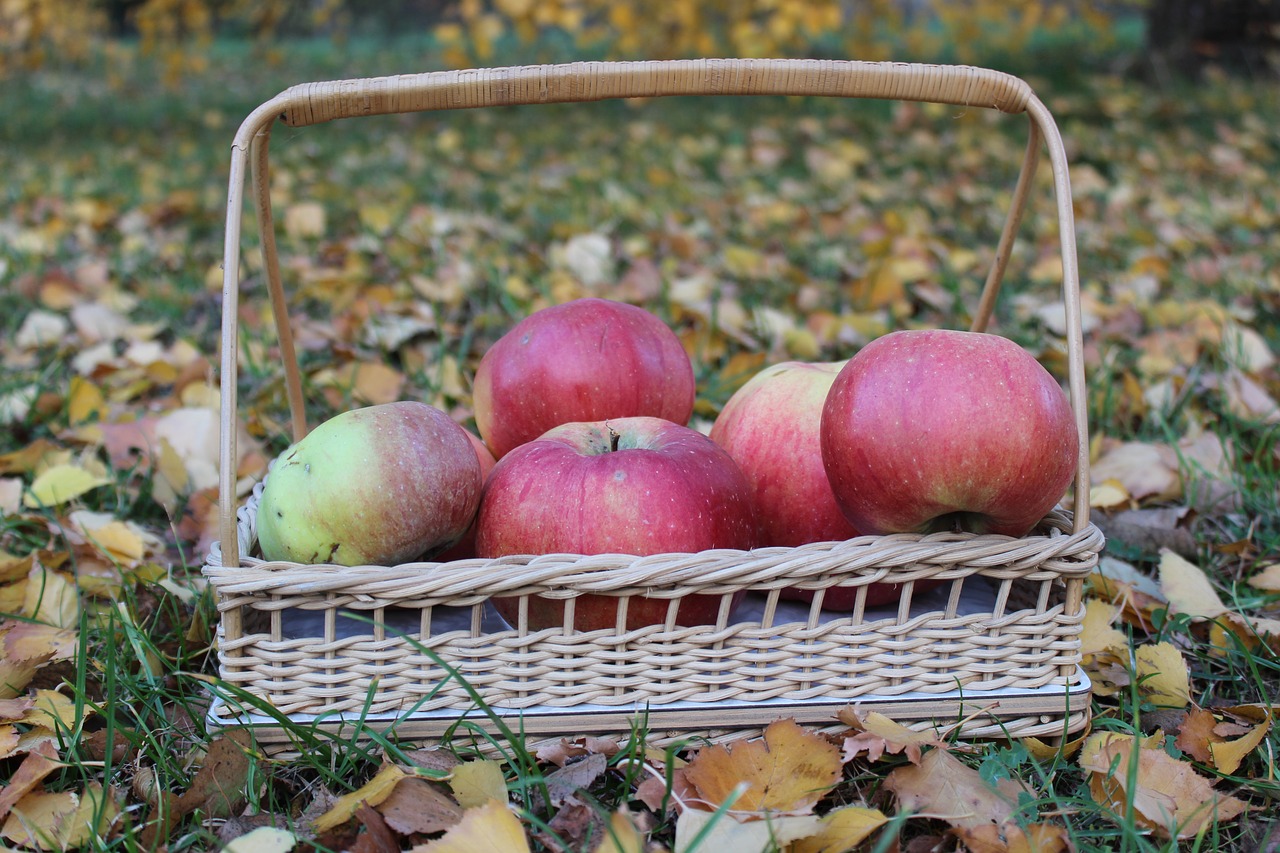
left=472, top=297, right=695, bottom=459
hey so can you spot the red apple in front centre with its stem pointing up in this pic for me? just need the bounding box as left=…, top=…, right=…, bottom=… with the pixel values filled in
left=476, top=418, right=756, bottom=630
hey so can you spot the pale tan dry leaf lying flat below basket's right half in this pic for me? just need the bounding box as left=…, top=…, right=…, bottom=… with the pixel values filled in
left=884, top=749, right=1029, bottom=827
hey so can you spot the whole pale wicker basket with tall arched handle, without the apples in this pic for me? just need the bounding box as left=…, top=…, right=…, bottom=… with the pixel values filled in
left=204, top=59, right=1103, bottom=739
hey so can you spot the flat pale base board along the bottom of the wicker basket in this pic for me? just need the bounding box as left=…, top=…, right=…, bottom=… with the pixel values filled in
left=207, top=667, right=1092, bottom=754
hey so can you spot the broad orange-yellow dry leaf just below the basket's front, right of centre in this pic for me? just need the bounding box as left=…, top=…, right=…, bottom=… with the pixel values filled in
left=685, top=720, right=841, bottom=812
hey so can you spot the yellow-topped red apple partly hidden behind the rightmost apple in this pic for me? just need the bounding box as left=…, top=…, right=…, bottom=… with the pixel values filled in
left=710, top=361, right=931, bottom=610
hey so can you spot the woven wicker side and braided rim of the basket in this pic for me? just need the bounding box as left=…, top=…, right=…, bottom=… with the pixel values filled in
left=205, top=487, right=1102, bottom=713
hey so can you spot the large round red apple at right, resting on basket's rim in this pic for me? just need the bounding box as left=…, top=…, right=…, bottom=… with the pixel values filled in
left=820, top=329, right=1079, bottom=537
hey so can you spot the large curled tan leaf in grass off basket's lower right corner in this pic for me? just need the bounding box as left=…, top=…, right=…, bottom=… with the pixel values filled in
left=1080, top=733, right=1247, bottom=838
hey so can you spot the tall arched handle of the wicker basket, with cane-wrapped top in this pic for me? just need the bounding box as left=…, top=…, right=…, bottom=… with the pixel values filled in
left=219, top=59, right=1089, bottom=566
